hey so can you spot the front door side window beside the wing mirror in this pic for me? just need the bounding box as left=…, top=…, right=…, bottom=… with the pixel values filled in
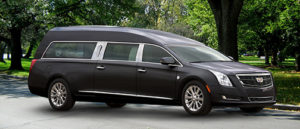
left=142, top=45, right=171, bottom=63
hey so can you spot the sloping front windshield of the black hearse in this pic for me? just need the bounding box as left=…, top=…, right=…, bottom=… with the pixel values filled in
left=168, top=45, right=232, bottom=63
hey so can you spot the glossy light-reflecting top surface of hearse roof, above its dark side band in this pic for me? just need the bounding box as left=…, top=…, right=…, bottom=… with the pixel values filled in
left=50, top=25, right=203, bottom=45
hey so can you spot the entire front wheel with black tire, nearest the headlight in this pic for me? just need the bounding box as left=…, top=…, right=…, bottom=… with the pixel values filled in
left=181, top=81, right=212, bottom=115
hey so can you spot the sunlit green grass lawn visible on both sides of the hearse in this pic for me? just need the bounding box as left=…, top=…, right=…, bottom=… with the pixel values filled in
left=0, top=56, right=300, bottom=105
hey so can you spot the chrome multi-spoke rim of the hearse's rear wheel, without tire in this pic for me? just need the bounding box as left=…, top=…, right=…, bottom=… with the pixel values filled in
left=50, top=82, right=67, bottom=107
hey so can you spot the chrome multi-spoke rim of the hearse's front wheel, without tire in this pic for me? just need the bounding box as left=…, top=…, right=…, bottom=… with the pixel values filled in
left=184, top=85, right=204, bottom=111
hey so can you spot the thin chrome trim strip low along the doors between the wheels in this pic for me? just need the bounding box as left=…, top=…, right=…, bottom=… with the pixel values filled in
left=79, top=90, right=173, bottom=100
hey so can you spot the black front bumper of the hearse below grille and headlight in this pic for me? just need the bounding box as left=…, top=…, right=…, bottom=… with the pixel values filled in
left=211, top=76, right=276, bottom=107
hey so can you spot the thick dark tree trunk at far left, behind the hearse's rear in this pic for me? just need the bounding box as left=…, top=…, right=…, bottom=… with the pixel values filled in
left=9, top=28, right=24, bottom=70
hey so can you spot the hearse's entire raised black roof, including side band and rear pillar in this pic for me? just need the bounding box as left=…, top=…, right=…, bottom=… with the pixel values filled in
left=35, top=25, right=204, bottom=58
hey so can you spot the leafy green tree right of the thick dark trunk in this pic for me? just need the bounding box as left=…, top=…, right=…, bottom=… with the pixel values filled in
left=239, top=0, right=299, bottom=66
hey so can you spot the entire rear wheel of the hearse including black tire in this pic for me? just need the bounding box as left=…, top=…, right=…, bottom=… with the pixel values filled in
left=48, top=79, right=75, bottom=111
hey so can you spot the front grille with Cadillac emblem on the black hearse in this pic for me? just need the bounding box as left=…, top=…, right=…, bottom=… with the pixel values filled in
left=237, top=73, right=273, bottom=87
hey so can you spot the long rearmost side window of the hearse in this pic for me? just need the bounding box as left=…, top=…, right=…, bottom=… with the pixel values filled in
left=43, top=42, right=96, bottom=59
